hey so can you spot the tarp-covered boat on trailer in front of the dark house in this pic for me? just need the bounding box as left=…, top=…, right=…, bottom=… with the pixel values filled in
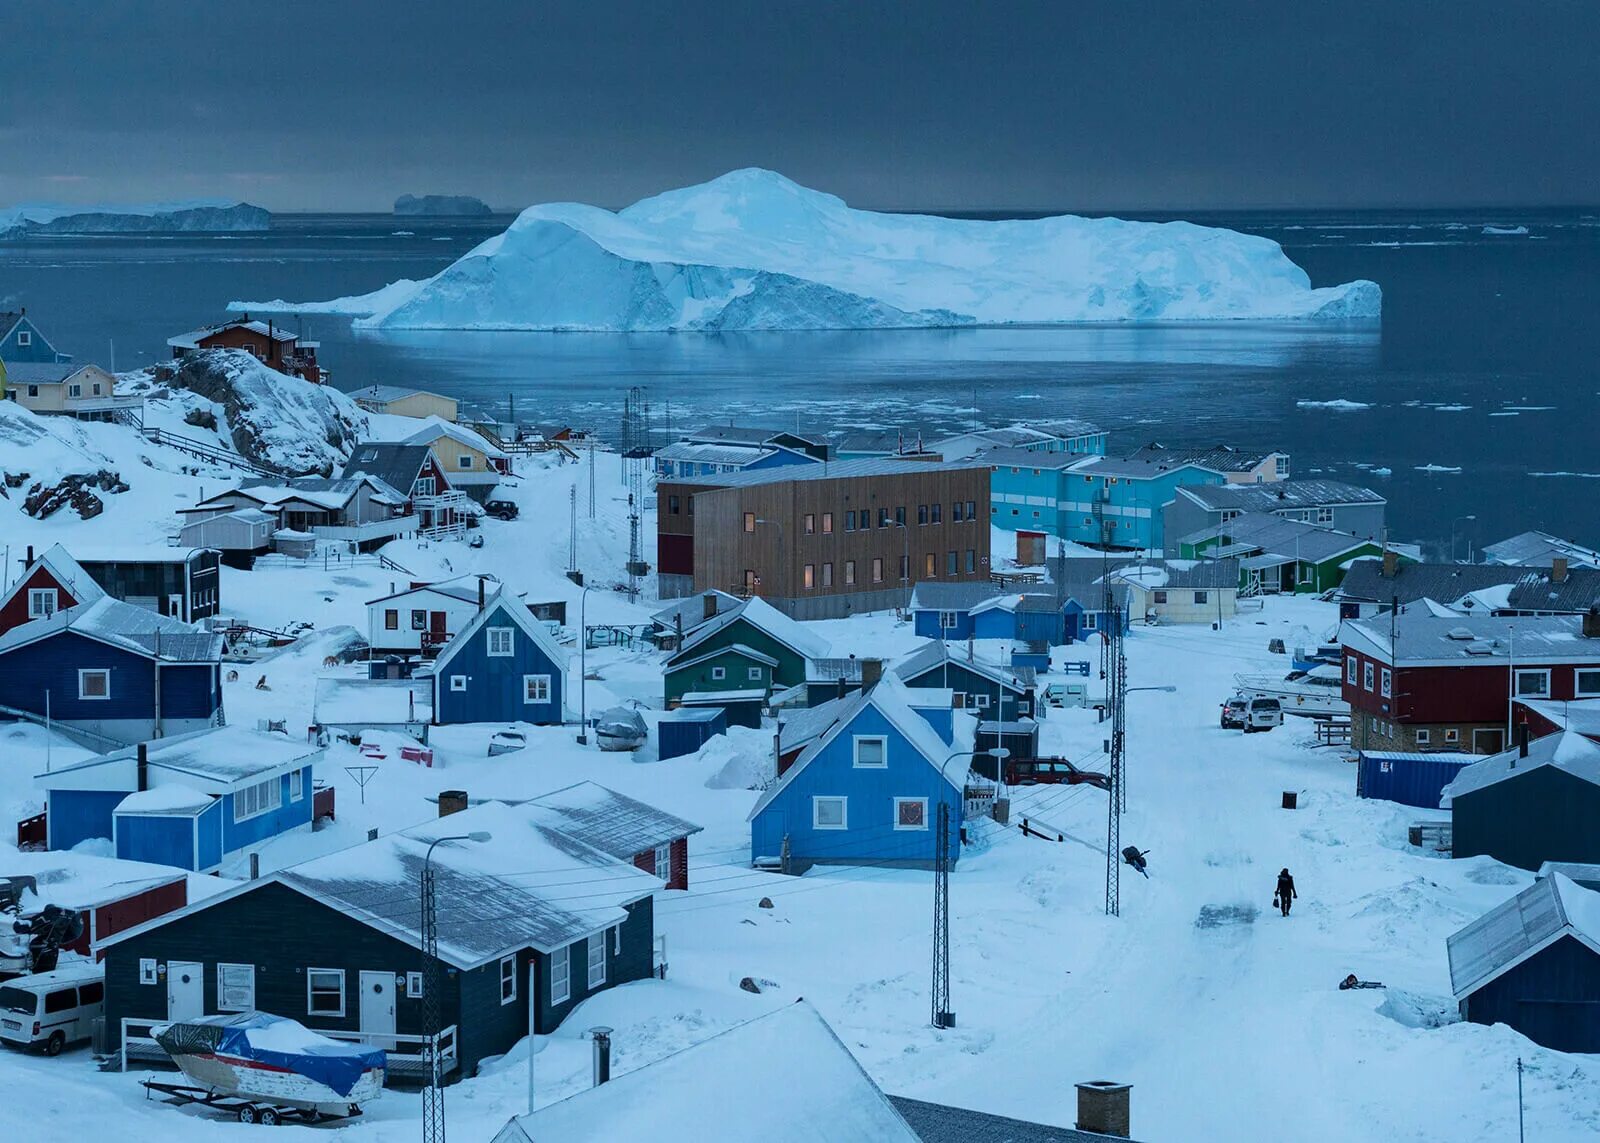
left=150, top=1012, right=387, bottom=1122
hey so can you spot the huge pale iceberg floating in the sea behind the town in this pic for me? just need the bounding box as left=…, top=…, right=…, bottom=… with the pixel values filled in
left=232, top=168, right=1382, bottom=330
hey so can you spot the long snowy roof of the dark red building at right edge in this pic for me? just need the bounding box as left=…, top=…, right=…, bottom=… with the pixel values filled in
left=1339, top=611, right=1600, bottom=666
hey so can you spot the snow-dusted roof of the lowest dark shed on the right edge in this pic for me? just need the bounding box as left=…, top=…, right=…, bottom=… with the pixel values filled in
left=1445, top=872, right=1600, bottom=1001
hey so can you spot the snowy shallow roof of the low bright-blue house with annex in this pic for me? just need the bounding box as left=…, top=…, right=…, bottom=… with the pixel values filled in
left=34, top=727, right=323, bottom=794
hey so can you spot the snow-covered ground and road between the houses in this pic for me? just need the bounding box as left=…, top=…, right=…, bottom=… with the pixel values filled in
left=0, top=413, right=1600, bottom=1143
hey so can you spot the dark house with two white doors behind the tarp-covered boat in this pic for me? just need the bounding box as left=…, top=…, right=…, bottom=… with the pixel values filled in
left=106, top=800, right=664, bottom=1079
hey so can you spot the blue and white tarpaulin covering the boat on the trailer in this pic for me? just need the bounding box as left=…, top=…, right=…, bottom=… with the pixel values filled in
left=154, top=1012, right=386, bottom=1095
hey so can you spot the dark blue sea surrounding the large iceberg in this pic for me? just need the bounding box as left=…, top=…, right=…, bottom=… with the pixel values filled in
left=0, top=208, right=1600, bottom=559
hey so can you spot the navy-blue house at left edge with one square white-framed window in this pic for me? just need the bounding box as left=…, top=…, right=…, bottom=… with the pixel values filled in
left=0, top=596, right=222, bottom=749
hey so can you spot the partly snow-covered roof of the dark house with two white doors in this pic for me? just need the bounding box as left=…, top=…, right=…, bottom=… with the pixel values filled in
left=106, top=802, right=662, bottom=970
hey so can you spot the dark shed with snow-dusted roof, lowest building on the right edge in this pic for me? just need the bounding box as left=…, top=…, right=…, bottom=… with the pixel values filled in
left=1448, top=872, right=1600, bottom=1052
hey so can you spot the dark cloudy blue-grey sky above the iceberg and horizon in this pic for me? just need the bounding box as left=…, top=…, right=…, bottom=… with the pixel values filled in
left=0, top=0, right=1600, bottom=210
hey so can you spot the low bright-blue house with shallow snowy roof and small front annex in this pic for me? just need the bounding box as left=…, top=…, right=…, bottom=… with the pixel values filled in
left=34, top=727, right=322, bottom=872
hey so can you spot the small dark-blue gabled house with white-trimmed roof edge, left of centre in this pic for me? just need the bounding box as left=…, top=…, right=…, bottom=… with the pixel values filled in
left=434, top=589, right=566, bottom=727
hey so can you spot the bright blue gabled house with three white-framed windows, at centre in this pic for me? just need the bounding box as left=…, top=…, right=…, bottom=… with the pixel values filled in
left=750, top=677, right=973, bottom=871
